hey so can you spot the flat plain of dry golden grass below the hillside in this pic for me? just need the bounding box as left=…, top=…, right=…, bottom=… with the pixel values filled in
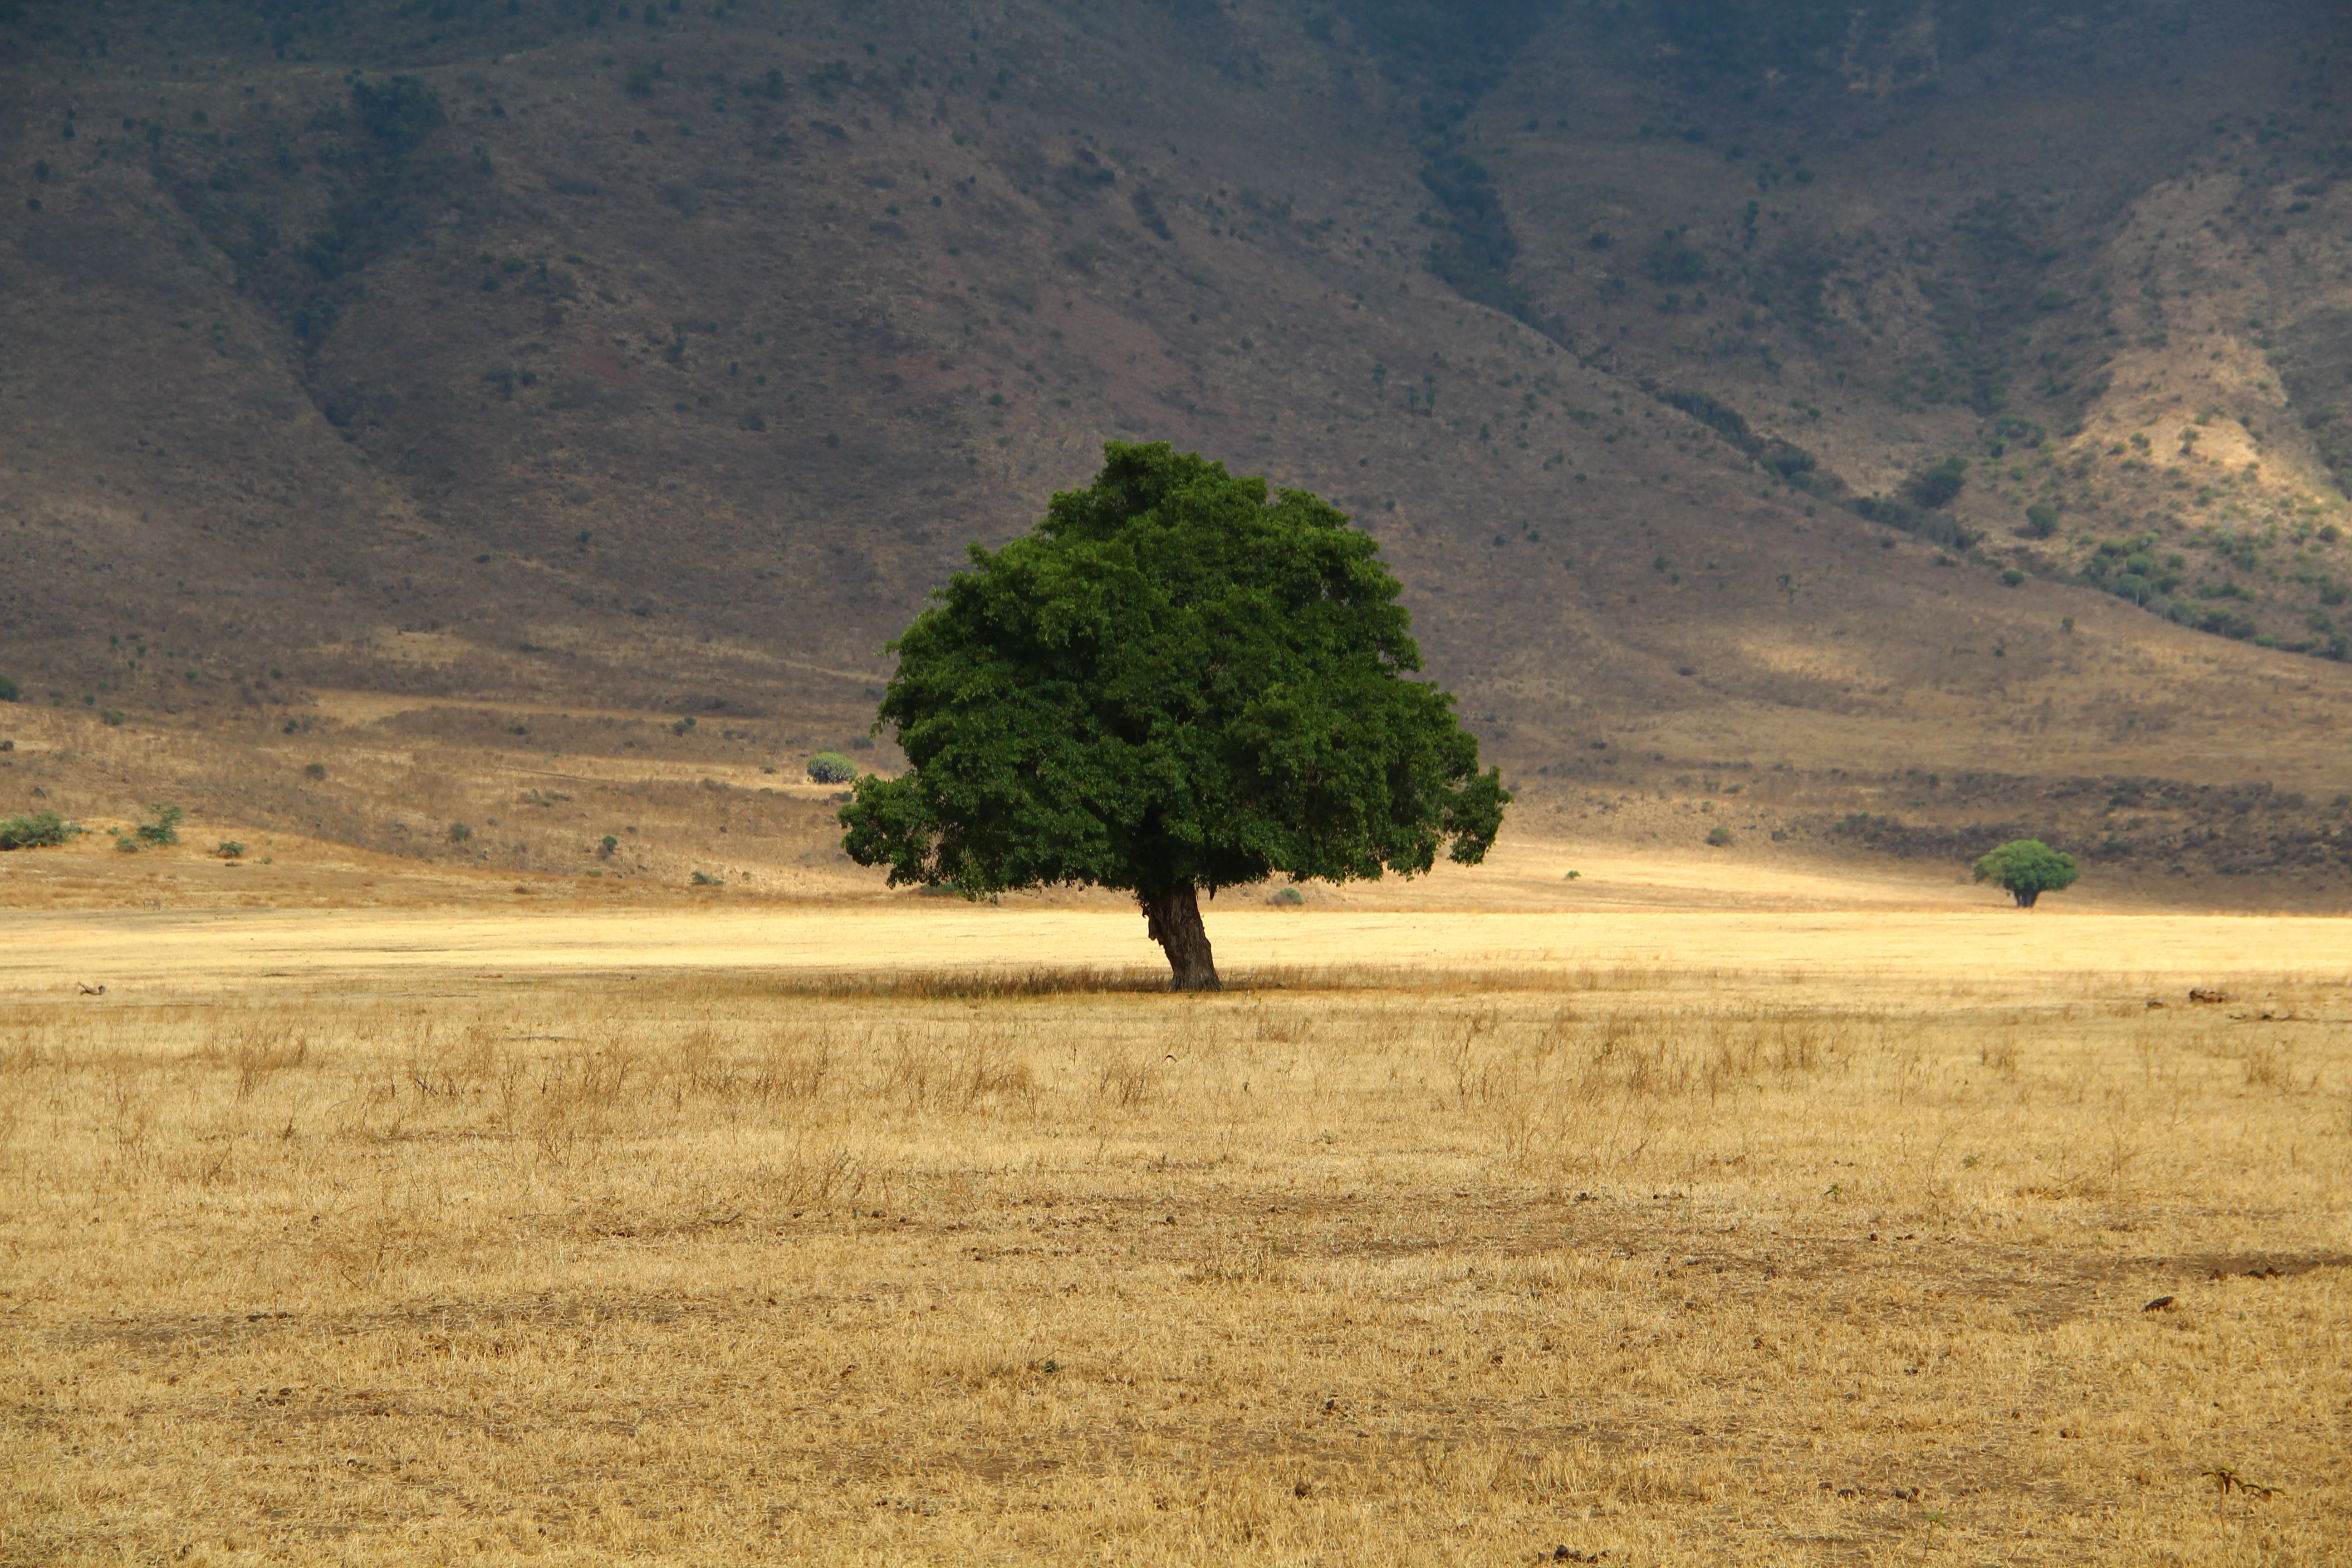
left=0, top=907, right=2352, bottom=1566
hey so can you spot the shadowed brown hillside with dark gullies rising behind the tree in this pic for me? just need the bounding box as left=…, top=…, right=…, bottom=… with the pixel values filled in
left=0, top=0, right=2352, bottom=900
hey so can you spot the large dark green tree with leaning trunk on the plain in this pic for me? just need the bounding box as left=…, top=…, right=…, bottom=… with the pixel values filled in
left=840, top=442, right=1510, bottom=990
